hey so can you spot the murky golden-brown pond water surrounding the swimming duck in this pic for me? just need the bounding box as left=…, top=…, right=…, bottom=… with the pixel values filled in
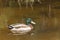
left=0, top=0, right=60, bottom=40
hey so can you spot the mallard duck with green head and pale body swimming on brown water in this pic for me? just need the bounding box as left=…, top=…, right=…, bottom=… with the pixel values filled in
left=8, top=18, right=36, bottom=35
